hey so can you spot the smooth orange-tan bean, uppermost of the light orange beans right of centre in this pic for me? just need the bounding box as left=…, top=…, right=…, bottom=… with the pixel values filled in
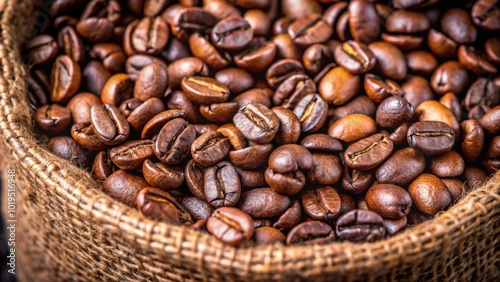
left=318, top=67, right=360, bottom=106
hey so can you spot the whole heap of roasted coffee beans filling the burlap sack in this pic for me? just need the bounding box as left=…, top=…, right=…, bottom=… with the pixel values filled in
left=24, top=0, right=500, bottom=245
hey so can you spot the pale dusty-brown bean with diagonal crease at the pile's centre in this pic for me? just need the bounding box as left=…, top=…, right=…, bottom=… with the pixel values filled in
left=233, top=103, right=279, bottom=144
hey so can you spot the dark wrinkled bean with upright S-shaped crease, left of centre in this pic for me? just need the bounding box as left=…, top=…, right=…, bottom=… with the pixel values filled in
left=155, top=118, right=196, bottom=165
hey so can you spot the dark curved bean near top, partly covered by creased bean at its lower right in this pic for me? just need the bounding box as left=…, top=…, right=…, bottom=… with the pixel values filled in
left=170, top=7, right=217, bottom=42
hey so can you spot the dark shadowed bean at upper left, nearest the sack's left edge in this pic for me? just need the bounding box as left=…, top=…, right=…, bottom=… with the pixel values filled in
left=25, top=34, right=59, bottom=65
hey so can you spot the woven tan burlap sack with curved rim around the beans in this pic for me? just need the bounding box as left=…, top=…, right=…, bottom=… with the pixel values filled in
left=0, top=0, right=500, bottom=281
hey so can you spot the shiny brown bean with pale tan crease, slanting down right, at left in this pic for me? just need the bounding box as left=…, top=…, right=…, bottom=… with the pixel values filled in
left=90, top=104, right=130, bottom=145
